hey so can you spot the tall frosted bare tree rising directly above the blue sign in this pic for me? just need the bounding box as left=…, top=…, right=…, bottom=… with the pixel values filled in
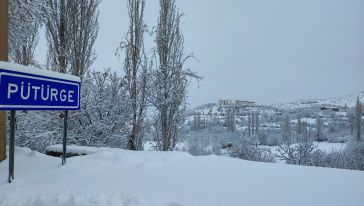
left=46, top=0, right=100, bottom=77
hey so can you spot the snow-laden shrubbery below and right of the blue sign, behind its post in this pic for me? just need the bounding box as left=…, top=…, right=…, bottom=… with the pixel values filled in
left=16, top=70, right=130, bottom=152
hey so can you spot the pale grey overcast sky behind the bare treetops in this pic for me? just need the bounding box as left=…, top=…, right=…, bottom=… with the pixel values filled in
left=39, top=0, right=364, bottom=106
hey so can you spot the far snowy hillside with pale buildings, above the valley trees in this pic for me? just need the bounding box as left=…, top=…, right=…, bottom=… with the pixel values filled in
left=186, top=93, right=364, bottom=138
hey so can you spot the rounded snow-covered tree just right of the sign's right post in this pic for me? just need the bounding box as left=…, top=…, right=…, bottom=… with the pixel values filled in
left=69, top=69, right=130, bottom=148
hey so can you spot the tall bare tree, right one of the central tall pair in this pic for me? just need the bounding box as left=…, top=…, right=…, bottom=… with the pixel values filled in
left=153, top=0, right=199, bottom=151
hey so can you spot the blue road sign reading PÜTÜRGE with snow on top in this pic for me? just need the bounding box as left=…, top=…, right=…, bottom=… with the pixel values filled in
left=0, top=62, right=81, bottom=110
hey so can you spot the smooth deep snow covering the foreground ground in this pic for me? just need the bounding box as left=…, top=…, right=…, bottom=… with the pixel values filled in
left=0, top=148, right=364, bottom=206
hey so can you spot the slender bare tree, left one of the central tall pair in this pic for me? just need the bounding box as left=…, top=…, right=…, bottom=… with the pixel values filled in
left=120, top=0, right=150, bottom=150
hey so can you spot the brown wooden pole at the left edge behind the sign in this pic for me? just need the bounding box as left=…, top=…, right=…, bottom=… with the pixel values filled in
left=0, top=0, right=8, bottom=162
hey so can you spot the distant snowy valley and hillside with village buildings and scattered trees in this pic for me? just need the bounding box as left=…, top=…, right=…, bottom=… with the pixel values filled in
left=185, top=92, right=364, bottom=169
